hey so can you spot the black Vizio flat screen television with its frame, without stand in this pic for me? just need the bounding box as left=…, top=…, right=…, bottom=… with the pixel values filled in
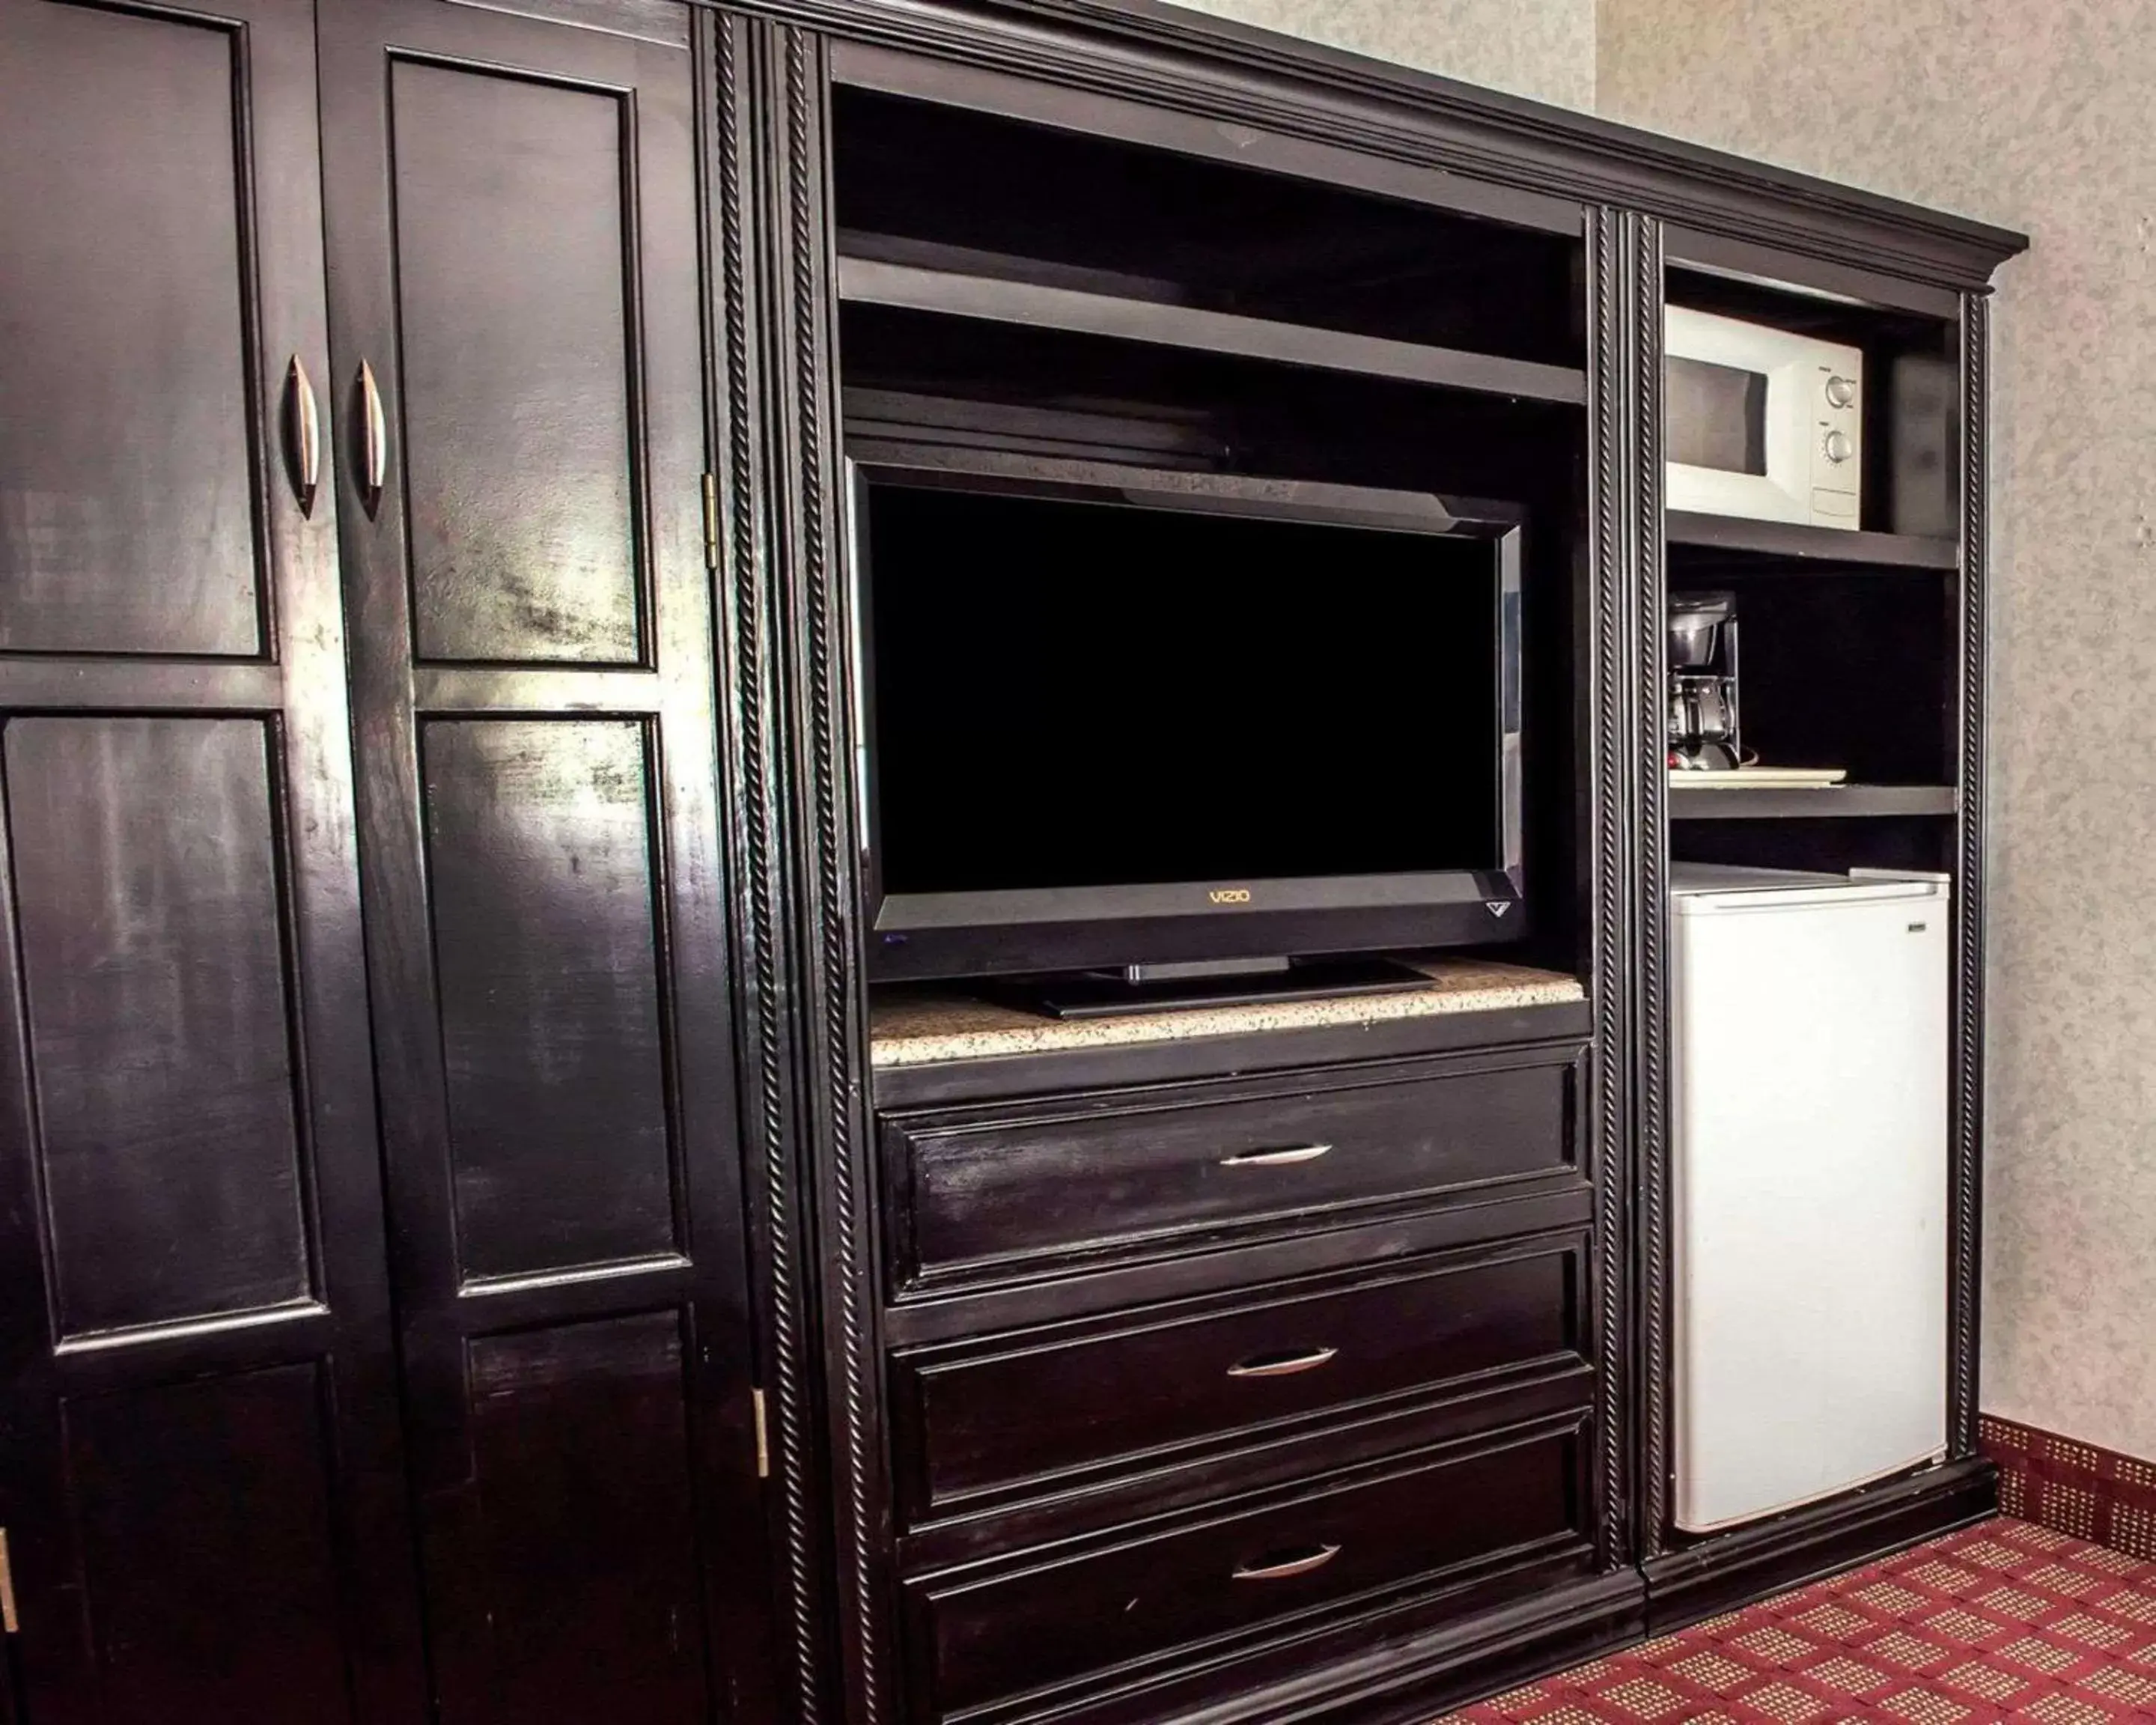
left=850, top=451, right=1526, bottom=979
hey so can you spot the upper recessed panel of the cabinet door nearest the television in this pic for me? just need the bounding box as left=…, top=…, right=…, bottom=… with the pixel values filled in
left=390, top=56, right=640, bottom=664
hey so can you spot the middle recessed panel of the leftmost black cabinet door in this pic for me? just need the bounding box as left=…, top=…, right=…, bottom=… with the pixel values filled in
left=4, top=718, right=314, bottom=1339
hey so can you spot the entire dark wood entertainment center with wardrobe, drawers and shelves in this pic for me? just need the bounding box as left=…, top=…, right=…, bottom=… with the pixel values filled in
left=0, top=0, right=2026, bottom=1725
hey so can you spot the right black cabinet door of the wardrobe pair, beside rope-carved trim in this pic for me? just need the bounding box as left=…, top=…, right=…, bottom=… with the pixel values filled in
left=321, top=0, right=764, bottom=1725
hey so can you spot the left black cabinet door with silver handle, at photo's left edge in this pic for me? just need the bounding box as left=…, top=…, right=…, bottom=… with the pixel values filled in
left=0, top=0, right=424, bottom=1725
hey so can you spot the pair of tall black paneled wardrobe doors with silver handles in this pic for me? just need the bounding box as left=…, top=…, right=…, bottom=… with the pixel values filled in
left=0, top=0, right=774, bottom=1725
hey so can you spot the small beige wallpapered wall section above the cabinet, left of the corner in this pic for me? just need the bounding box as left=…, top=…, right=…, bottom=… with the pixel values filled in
left=1155, top=0, right=1595, bottom=108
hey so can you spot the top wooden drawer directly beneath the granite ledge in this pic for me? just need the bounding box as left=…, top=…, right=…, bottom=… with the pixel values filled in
left=882, top=1044, right=1580, bottom=1289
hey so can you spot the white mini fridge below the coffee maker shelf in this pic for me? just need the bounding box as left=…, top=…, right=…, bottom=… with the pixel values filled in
left=1671, top=865, right=1949, bottom=1533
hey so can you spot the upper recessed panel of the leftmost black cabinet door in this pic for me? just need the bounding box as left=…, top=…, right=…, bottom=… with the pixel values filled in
left=0, top=4, right=265, bottom=654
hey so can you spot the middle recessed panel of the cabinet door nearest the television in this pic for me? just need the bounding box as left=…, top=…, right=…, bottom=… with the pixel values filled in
left=422, top=718, right=677, bottom=1281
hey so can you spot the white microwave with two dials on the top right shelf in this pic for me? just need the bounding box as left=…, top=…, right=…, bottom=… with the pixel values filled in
left=1662, top=306, right=1865, bottom=529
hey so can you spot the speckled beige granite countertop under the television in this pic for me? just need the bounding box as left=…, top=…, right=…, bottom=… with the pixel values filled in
left=869, top=958, right=1585, bottom=1068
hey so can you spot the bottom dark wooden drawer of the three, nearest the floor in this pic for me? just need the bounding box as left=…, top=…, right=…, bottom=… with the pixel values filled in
left=907, top=1426, right=1585, bottom=1718
